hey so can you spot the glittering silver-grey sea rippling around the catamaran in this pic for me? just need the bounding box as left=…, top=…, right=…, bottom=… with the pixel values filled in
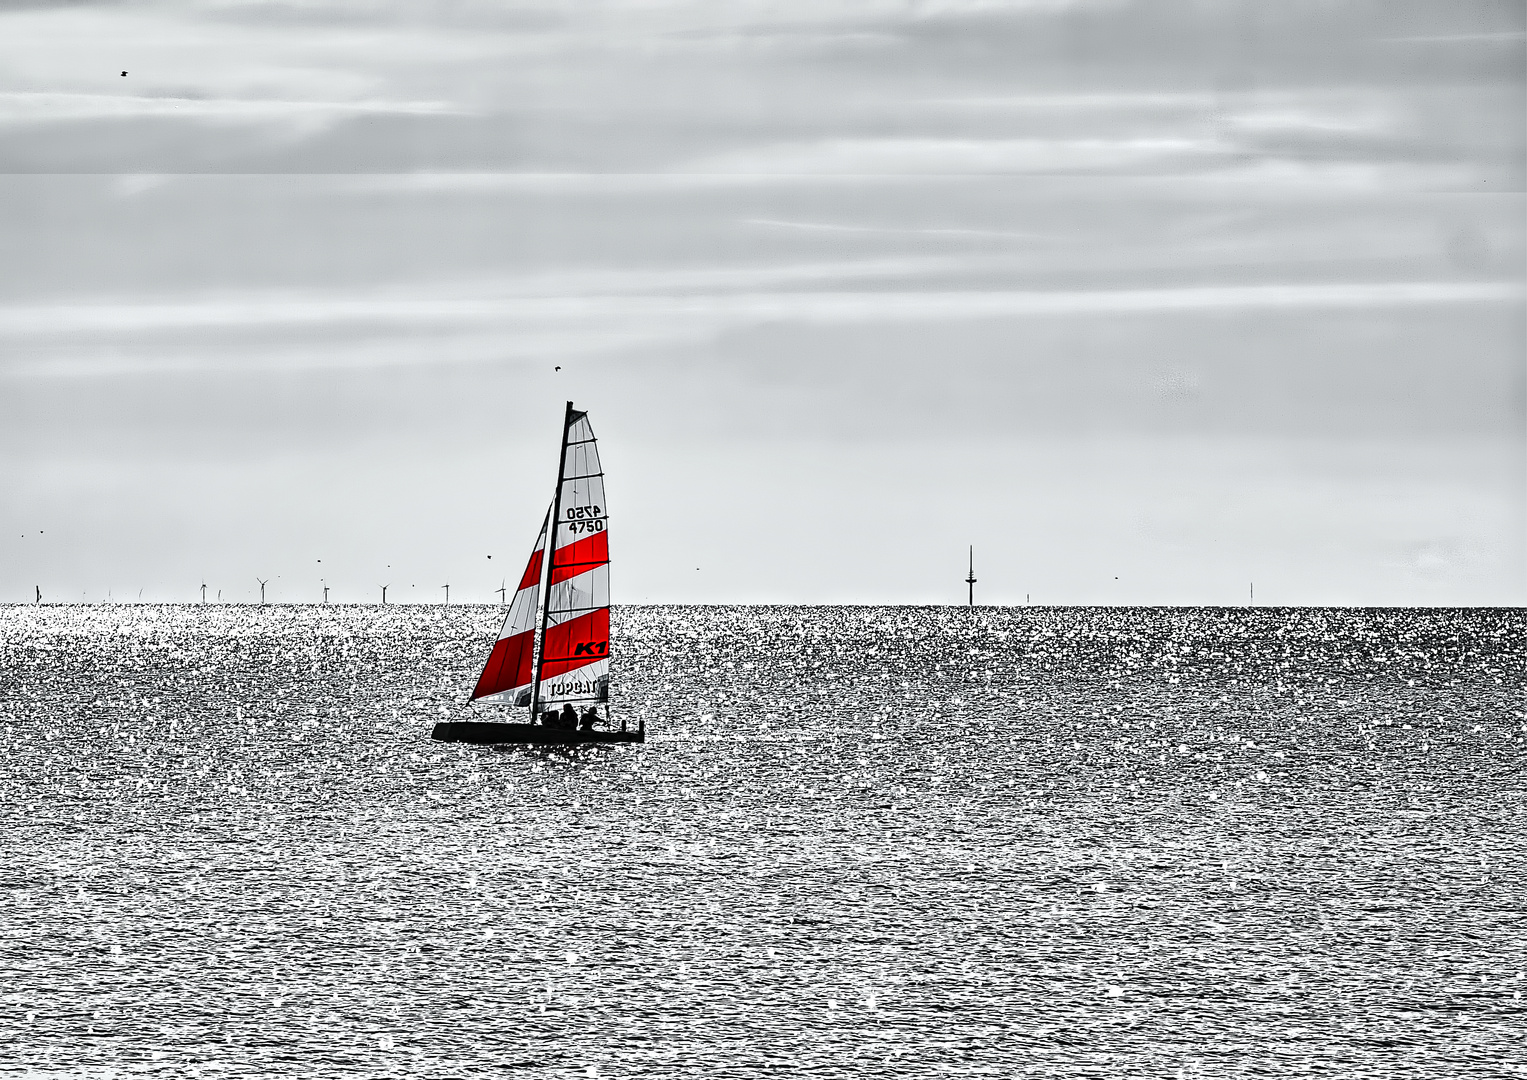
left=0, top=605, right=1527, bottom=1078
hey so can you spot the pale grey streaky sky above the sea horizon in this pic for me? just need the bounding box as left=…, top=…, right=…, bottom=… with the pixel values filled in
left=0, top=0, right=1527, bottom=605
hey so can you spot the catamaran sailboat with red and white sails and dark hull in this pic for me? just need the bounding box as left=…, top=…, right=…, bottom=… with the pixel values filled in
left=431, top=402, right=646, bottom=745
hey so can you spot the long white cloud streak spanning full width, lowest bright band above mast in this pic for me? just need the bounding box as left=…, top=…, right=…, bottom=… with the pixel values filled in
left=0, top=281, right=1524, bottom=377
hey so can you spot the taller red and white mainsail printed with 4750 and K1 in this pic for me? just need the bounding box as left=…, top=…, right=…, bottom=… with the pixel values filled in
left=538, top=403, right=609, bottom=704
